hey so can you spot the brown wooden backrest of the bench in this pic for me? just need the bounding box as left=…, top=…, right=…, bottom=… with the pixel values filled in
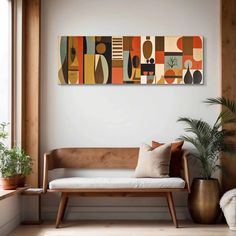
left=48, top=148, right=139, bottom=170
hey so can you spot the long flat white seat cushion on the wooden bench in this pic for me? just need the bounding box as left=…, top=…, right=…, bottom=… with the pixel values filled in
left=49, top=177, right=185, bottom=189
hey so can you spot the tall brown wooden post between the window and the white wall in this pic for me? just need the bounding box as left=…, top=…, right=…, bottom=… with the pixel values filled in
left=22, top=0, right=40, bottom=187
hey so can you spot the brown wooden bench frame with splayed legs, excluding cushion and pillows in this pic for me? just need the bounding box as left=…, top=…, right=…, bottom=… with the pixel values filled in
left=43, top=148, right=190, bottom=228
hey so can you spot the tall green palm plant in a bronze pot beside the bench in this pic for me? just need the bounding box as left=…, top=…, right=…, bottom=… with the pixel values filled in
left=178, top=99, right=236, bottom=224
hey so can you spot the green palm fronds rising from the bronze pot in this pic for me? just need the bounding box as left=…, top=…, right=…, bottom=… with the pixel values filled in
left=178, top=98, right=236, bottom=179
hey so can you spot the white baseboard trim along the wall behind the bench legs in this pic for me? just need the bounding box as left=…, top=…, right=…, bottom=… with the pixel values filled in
left=41, top=206, right=190, bottom=220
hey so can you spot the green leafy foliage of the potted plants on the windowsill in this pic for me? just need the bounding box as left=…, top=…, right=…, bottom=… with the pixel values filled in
left=0, top=123, right=32, bottom=178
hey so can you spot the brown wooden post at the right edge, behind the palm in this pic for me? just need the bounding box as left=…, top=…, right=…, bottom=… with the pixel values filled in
left=221, top=0, right=236, bottom=192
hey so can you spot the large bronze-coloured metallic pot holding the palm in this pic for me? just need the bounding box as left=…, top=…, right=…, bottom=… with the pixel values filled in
left=188, top=179, right=220, bottom=224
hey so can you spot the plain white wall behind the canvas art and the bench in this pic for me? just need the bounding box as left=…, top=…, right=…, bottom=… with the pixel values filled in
left=41, top=0, right=220, bottom=218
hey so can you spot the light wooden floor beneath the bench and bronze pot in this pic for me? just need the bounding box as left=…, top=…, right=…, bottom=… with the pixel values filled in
left=10, top=221, right=236, bottom=236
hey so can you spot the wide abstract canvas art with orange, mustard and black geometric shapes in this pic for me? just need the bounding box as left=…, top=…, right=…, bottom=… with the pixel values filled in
left=58, top=36, right=203, bottom=85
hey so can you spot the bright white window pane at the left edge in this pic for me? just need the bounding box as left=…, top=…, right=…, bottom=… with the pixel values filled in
left=0, top=0, right=12, bottom=144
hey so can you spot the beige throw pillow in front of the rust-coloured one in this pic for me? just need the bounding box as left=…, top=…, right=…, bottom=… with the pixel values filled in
left=134, top=144, right=171, bottom=178
